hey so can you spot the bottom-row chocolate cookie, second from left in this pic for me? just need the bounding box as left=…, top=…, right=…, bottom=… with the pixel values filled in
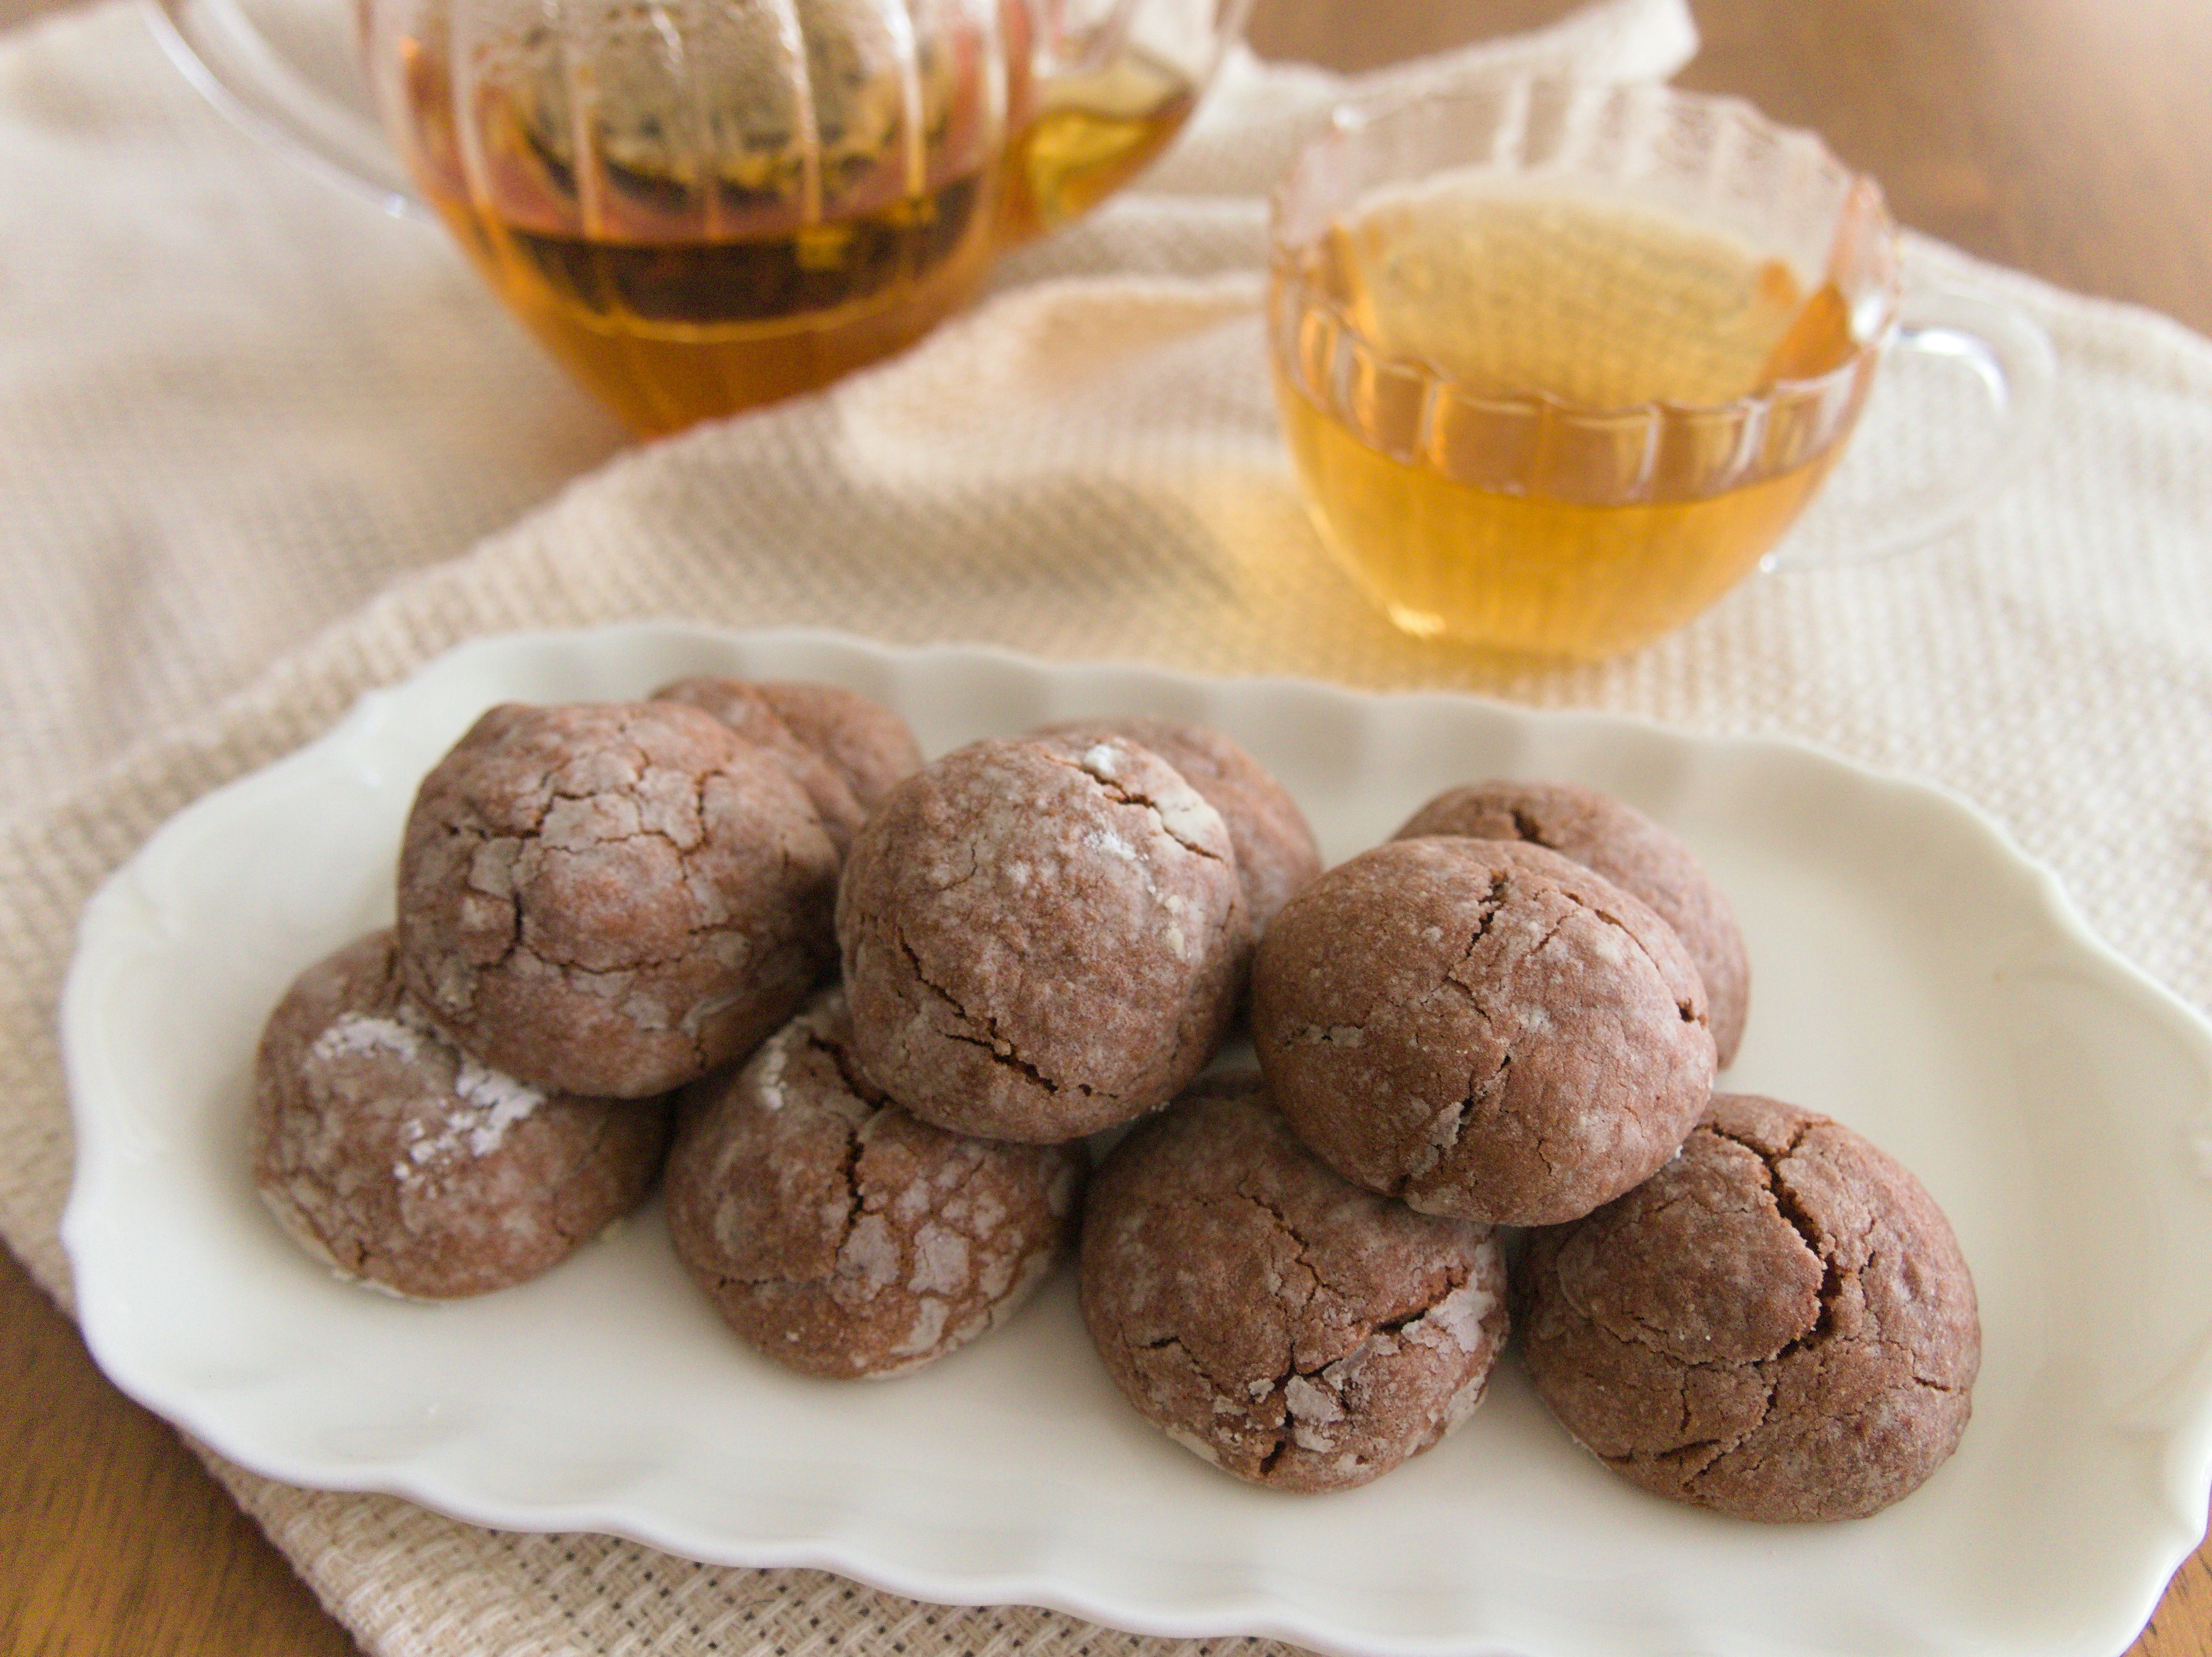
left=668, top=991, right=1088, bottom=1378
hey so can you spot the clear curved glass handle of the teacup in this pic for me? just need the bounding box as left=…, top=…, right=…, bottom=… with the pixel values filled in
left=1763, top=290, right=2057, bottom=571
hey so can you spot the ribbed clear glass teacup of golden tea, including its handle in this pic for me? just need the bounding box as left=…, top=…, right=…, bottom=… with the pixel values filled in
left=1270, top=82, right=2051, bottom=659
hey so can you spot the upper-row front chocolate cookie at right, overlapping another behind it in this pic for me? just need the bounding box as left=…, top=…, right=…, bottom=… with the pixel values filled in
left=1252, top=838, right=1714, bottom=1225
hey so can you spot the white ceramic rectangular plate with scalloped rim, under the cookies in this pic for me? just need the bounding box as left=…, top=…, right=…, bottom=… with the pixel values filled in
left=62, top=626, right=2212, bottom=1657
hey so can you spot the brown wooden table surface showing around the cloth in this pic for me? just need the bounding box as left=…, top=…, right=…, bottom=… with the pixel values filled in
left=13, top=0, right=2212, bottom=1657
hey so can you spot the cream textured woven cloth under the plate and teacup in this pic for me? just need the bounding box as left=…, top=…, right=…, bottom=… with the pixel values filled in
left=0, top=0, right=2212, bottom=1657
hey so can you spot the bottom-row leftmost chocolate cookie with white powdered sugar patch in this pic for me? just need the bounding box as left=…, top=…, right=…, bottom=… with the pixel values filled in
left=252, top=932, right=668, bottom=1301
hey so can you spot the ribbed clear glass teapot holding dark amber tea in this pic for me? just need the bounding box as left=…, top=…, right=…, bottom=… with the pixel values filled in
left=161, top=0, right=1250, bottom=434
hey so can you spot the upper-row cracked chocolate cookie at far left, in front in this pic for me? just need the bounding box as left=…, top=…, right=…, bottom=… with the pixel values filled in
left=398, top=701, right=836, bottom=1098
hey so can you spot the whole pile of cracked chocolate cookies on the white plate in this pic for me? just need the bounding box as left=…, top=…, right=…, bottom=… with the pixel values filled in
left=255, top=679, right=1980, bottom=1520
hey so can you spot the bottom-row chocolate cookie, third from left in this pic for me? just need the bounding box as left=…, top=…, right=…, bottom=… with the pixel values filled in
left=1082, top=1070, right=1506, bottom=1491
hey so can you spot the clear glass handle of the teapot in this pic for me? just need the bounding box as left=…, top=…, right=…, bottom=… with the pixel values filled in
left=144, top=0, right=429, bottom=219
